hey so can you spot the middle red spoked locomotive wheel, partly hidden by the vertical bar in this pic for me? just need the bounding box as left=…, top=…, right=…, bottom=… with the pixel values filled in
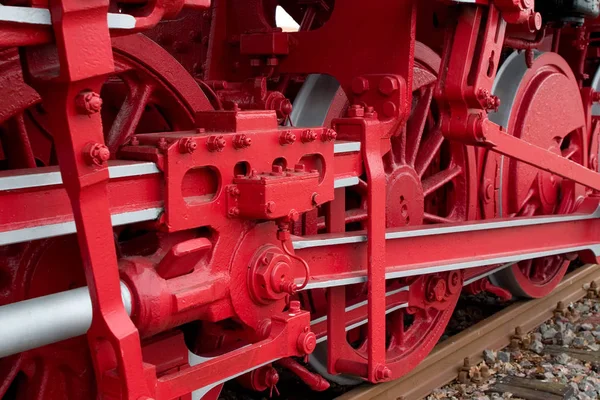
left=292, top=43, right=477, bottom=385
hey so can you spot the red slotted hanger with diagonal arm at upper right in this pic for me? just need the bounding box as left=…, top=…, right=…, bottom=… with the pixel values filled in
left=437, top=2, right=600, bottom=190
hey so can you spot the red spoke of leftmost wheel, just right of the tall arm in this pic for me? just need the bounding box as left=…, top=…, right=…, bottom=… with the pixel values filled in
left=106, top=83, right=154, bottom=152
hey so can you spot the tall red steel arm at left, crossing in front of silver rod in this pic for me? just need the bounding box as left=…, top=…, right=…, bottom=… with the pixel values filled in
left=24, top=0, right=149, bottom=400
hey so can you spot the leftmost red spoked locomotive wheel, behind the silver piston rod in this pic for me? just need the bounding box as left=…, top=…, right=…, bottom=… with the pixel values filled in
left=0, top=35, right=214, bottom=399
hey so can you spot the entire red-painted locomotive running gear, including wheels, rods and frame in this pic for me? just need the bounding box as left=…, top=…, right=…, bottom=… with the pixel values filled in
left=0, top=0, right=600, bottom=400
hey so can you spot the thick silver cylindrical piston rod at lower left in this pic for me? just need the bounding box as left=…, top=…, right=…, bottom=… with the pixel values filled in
left=0, top=282, right=131, bottom=358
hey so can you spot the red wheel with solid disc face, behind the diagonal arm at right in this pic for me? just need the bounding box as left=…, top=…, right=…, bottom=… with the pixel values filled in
left=484, top=53, right=588, bottom=298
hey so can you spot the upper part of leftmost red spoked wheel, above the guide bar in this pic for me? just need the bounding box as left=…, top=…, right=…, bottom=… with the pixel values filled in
left=0, top=35, right=211, bottom=168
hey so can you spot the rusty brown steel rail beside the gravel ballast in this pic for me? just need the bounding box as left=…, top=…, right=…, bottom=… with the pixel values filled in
left=337, top=264, right=600, bottom=400
